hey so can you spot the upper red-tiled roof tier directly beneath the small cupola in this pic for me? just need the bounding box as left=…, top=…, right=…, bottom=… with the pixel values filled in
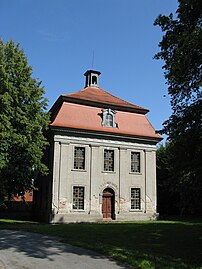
left=63, top=87, right=149, bottom=114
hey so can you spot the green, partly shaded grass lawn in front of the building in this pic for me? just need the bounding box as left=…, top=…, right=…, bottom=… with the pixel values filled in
left=0, top=220, right=202, bottom=269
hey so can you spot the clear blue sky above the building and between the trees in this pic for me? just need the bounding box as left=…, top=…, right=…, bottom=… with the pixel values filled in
left=0, top=0, right=177, bottom=138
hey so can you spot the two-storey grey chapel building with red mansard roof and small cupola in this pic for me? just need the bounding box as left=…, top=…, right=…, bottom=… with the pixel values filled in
left=34, top=70, right=161, bottom=223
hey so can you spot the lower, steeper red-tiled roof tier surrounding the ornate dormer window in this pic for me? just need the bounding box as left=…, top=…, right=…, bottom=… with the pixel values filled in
left=51, top=101, right=161, bottom=140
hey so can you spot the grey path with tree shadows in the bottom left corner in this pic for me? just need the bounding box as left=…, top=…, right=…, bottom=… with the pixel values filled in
left=0, top=230, right=129, bottom=269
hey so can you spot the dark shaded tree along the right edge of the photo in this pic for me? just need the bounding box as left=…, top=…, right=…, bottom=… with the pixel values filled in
left=154, top=0, right=202, bottom=214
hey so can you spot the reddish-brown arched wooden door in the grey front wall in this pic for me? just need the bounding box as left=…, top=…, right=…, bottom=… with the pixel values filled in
left=102, top=188, right=115, bottom=219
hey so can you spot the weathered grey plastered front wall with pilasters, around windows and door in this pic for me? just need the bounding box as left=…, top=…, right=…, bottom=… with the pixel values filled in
left=52, top=132, right=156, bottom=222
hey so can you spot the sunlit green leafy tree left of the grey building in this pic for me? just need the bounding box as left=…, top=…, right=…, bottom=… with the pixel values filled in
left=0, top=40, right=49, bottom=201
